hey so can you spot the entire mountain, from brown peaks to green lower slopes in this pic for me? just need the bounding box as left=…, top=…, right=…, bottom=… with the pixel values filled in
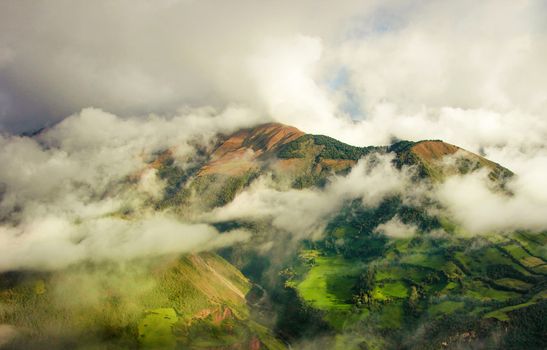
left=0, top=123, right=547, bottom=350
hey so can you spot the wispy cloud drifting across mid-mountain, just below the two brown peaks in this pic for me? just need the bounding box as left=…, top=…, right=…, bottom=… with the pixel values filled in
left=205, top=154, right=410, bottom=238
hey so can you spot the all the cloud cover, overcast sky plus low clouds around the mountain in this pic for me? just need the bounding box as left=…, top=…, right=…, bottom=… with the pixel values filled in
left=0, top=0, right=547, bottom=269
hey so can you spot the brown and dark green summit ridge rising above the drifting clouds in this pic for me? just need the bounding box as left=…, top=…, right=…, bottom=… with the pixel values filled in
left=198, top=123, right=513, bottom=185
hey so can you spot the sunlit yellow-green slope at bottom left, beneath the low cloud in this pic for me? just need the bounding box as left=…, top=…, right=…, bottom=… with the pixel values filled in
left=0, top=253, right=283, bottom=349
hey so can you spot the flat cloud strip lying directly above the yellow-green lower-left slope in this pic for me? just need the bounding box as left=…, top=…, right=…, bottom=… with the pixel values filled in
left=0, top=214, right=249, bottom=271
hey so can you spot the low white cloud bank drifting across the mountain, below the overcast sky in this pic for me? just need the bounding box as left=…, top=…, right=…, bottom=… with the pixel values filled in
left=0, top=108, right=547, bottom=271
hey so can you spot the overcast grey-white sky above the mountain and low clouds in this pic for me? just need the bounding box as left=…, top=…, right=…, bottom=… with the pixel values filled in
left=0, top=0, right=547, bottom=141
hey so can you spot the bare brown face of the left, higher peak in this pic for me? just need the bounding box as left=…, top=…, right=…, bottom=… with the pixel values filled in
left=198, top=123, right=304, bottom=176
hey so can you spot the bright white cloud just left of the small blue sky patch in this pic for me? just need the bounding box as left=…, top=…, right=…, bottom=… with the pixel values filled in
left=250, top=35, right=342, bottom=133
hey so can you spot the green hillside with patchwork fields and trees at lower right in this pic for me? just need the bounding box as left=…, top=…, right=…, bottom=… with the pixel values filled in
left=286, top=226, right=547, bottom=349
